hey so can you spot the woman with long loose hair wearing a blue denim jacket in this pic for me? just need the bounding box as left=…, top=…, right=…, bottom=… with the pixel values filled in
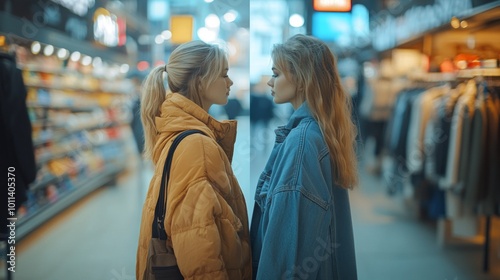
left=251, top=35, right=357, bottom=280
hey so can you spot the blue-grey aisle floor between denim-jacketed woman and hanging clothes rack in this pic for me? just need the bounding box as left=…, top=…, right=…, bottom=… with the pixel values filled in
left=351, top=169, right=500, bottom=280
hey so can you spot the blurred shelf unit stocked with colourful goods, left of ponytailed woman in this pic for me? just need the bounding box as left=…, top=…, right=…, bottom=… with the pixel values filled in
left=16, top=43, right=133, bottom=243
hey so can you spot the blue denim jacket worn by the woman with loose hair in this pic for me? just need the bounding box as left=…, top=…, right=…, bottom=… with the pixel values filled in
left=250, top=103, right=357, bottom=280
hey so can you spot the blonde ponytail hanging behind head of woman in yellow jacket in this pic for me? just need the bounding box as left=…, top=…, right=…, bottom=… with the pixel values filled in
left=141, top=66, right=166, bottom=158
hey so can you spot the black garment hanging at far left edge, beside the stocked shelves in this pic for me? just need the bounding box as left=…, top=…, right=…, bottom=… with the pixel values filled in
left=0, top=49, right=37, bottom=236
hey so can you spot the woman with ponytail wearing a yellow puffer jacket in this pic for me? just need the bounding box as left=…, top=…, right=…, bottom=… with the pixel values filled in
left=136, top=41, right=252, bottom=279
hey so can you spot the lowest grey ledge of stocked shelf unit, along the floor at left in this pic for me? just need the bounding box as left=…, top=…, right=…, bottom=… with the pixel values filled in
left=16, top=166, right=125, bottom=240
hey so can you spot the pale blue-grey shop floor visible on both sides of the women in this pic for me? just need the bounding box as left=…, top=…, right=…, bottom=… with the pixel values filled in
left=2, top=115, right=500, bottom=280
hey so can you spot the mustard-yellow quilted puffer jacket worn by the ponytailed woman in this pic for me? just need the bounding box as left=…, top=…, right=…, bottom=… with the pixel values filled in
left=136, top=93, right=252, bottom=280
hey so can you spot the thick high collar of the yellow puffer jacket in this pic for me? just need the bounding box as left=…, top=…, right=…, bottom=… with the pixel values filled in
left=153, top=93, right=237, bottom=162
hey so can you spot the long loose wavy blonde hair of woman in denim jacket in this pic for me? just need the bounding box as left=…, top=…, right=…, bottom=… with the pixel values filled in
left=272, top=34, right=358, bottom=189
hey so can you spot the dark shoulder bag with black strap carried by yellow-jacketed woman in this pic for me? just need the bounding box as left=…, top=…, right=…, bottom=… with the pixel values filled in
left=143, top=130, right=205, bottom=280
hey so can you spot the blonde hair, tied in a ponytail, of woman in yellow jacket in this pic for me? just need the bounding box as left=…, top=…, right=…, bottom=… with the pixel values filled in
left=141, top=41, right=227, bottom=158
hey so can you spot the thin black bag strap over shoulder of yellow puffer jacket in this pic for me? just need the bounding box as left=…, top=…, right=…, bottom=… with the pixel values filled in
left=153, top=129, right=206, bottom=240
